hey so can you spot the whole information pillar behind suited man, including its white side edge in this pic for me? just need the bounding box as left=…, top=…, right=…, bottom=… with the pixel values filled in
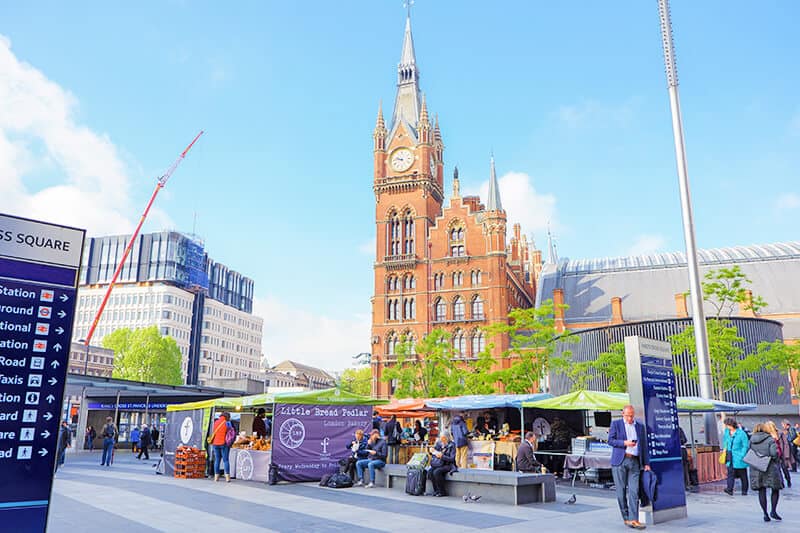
left=625, top=337, right=686, bottom=524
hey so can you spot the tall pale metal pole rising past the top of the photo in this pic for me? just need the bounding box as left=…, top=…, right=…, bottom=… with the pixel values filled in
left=658, top=0, right=722, bottom=406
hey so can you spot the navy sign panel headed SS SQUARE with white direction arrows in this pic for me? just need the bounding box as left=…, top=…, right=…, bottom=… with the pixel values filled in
left=0, top=214, right=85, bottom=532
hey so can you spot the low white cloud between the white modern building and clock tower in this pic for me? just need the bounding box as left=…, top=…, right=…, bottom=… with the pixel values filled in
left=253, top=296, right=372, bottom=371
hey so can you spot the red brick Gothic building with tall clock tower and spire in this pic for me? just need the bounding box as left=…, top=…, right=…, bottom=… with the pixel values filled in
left=372, top=19, right=542, bottom=396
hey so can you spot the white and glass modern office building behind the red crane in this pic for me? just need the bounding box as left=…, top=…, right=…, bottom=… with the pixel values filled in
left=73, top=231, right=263, bottom=385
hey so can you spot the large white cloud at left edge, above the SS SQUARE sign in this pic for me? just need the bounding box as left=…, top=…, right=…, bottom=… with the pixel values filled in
left=0, top=36, right=132, bottom=234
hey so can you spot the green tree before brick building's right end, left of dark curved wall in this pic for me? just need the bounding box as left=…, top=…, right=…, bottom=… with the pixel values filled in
left=486, top=300, right=577, bottom=393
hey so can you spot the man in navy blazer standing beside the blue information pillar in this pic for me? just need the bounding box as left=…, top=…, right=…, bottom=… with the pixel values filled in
left=608, top=405, right=650, bottom=529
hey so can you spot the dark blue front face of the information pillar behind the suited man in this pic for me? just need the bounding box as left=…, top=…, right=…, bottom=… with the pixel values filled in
left=641, top=354, right=686, bottom=511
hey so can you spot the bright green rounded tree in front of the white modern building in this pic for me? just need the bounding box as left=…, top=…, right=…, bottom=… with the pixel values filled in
left=103, top=326, right=183, bottom=385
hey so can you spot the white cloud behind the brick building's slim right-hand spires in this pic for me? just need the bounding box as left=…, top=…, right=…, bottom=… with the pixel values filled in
left=464, top=172, right=558, bottom=239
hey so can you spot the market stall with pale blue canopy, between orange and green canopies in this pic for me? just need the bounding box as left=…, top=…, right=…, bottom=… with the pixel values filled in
left=425, top=393, right=551, bottom=470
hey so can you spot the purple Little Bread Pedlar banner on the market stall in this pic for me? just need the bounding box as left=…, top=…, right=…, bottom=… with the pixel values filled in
left=272, top=404, right=372, bottom=481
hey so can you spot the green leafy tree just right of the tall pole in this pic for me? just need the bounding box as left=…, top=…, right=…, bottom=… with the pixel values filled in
left=669, top=265, right=767, bottom=400
